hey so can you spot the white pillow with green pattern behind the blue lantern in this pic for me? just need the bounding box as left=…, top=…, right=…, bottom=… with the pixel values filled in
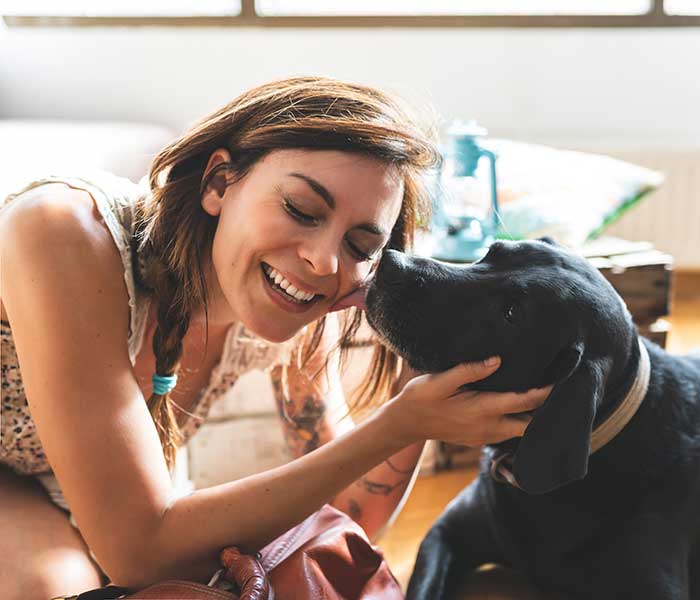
left=479, top=139, right=664, bottom=247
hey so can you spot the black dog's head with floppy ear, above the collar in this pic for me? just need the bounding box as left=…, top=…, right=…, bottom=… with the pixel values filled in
left=366, top=238, right=636, bottom=493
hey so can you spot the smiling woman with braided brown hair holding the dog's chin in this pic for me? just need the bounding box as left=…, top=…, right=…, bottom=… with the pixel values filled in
left=0, top=78, right=546, bottom=599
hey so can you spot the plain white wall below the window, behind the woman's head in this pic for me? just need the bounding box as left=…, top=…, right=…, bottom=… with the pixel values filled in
left=0, top=28, right=700, bottom=144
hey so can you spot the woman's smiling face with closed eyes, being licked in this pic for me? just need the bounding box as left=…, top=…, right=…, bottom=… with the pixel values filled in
left=202, top=150, right=403, bottom=342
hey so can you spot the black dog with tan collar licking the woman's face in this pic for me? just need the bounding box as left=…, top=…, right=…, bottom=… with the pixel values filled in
left=367, top=239, right=700, bottom=600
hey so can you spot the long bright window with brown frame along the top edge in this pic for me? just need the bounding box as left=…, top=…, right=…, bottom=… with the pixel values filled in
left=0, top=0, right=700, bottom=27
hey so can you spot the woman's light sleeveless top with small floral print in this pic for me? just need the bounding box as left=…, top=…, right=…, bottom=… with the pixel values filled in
left=0, top=171, right=298, bottom=475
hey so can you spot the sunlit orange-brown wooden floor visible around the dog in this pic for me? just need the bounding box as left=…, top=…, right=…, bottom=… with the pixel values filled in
left=378, top=272, right=700, bottom=600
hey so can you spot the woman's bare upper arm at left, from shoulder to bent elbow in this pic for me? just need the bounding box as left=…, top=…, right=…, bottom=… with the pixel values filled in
left=0, top=190, right=172, bottom=579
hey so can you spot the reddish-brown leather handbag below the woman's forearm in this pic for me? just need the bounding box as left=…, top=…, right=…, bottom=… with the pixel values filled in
left=52, top=504, right=404, bottom=600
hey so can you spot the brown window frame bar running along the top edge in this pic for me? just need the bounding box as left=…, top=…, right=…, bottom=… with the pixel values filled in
left=2, top=0, right=700, bottom=29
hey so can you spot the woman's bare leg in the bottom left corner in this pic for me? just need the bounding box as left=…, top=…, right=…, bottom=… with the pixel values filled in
left=0, top=465, right=102, bottom=600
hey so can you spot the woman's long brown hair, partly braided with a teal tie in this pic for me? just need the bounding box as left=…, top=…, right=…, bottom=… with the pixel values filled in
left=136, top=77, right=439, bottom=466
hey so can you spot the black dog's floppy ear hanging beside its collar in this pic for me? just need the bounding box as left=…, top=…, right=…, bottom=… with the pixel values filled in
left=513, top=344, right=607, bottom=494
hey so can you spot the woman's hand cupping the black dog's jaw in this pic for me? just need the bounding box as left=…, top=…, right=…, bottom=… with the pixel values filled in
left=387, top=357, right=552, bottom=446
